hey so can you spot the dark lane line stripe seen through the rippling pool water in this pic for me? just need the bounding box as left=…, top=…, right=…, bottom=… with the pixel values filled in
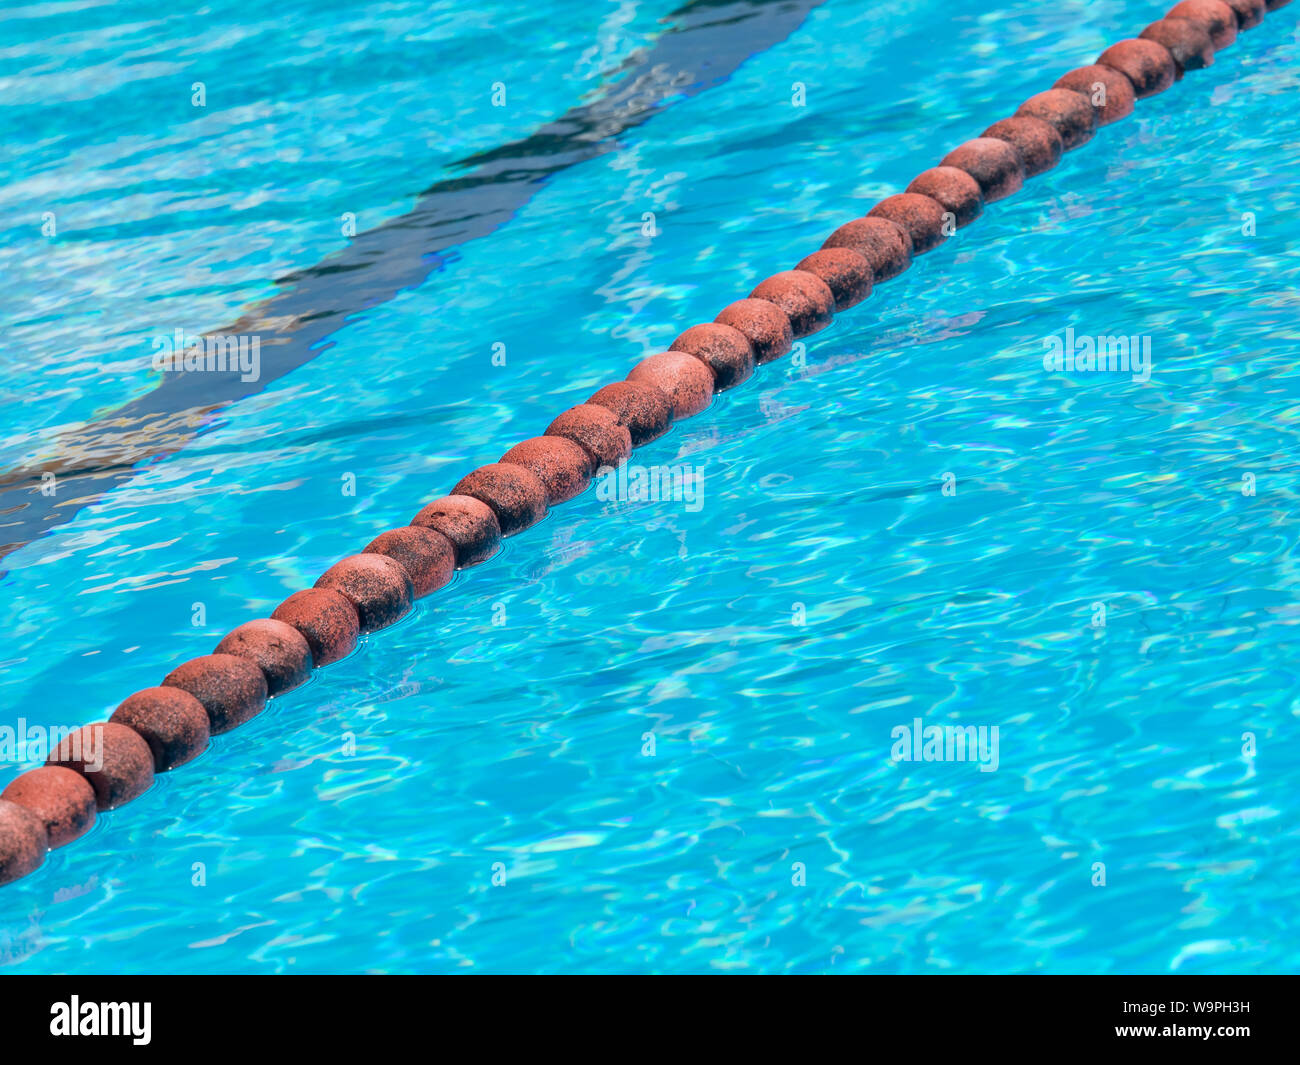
left=0, top=0, right=822, bottom=576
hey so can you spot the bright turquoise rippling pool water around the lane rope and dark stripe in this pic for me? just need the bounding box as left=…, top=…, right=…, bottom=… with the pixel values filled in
left=0, top=0, right=1300, bottom=973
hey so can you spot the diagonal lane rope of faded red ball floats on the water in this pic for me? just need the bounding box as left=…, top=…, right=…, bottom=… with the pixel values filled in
left=0, top=0, right=1290, bottom=884
